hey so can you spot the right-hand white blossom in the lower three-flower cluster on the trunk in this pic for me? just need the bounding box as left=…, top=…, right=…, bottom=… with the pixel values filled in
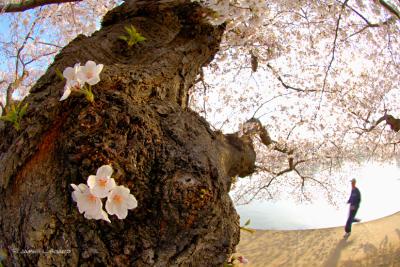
left=106, top=186, right=137, bottom=219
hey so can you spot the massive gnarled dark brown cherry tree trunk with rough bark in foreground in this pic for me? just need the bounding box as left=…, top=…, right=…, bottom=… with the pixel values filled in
left=0, top=1, right=255, bottom=266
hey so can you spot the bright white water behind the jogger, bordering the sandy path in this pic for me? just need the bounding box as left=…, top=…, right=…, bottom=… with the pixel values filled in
left=236, top=163, right=400, bottom=230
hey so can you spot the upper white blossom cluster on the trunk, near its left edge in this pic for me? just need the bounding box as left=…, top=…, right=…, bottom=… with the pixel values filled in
left=60, top=60, right=103, bottom=102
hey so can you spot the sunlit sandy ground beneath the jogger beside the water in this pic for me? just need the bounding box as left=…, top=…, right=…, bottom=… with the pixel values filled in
left=237, top=212, right=400, bottom=267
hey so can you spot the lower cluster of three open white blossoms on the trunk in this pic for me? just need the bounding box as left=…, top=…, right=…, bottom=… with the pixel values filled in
left=71, top=165, right=137, bottom=223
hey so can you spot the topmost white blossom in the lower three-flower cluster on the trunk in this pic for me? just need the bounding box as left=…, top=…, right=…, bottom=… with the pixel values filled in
left=87, top=165, right=115, bottom=198
